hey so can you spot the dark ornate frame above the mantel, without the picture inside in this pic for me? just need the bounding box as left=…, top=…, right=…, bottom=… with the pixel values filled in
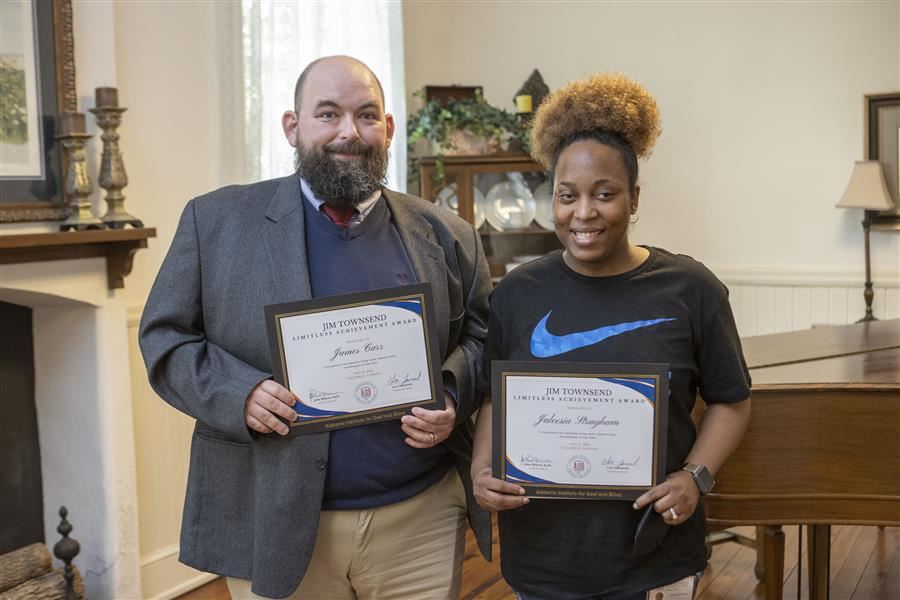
left=0, top=0, right=77, bottom=223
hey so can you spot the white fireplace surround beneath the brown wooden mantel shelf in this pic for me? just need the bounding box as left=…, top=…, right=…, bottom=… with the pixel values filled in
left=0, top=258, right=141, bottom=599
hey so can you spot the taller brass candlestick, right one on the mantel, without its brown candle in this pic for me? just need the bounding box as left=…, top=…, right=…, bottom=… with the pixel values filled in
left=89, top=106, right=144, bottom=229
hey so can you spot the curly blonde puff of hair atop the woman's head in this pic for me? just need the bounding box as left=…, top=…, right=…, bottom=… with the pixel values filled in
left=531, top=73, right=662, bottom=171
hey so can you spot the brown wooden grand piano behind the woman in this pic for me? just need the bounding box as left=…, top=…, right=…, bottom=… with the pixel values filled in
left=697, top=320, right=900, bottom=600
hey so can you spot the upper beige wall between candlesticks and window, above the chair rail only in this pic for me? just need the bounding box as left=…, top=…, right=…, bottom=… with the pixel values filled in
left=114, top=1, right=232, bottom=306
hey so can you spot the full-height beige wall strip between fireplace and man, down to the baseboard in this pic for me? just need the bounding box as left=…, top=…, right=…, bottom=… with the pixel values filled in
left=112, top=1, right=226, bottom=598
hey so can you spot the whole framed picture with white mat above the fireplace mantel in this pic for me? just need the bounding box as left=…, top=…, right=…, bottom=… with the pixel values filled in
left=0, top=0, right=77, bottom=223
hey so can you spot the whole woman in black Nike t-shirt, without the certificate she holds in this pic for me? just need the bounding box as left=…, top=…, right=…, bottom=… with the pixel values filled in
left=472, top=75, right=750, bottom=600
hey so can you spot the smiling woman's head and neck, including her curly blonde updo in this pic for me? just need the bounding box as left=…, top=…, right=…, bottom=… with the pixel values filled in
left=532, top=75, right=660, bottom=276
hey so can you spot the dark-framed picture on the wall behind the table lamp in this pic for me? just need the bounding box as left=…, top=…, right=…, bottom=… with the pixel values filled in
left=865, top=92, right=900, bottom=230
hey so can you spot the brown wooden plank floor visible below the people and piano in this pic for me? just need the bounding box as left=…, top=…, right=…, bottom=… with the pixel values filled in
left=180, top=525, right=900, bottom=600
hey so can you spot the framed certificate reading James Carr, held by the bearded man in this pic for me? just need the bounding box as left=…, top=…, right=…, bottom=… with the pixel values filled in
left=265, top=284, right=444, bottom=433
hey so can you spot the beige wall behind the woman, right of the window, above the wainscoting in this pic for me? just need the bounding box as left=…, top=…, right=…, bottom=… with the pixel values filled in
left=403, top=0, right=900, bottom=281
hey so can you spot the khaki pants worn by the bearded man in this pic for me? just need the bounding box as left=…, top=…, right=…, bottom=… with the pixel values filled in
left=227, top=467, right=466, bottom=600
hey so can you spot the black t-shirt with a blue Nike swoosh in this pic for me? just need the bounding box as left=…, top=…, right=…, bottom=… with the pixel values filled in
left=479, top=247, right=750, bottom=600
